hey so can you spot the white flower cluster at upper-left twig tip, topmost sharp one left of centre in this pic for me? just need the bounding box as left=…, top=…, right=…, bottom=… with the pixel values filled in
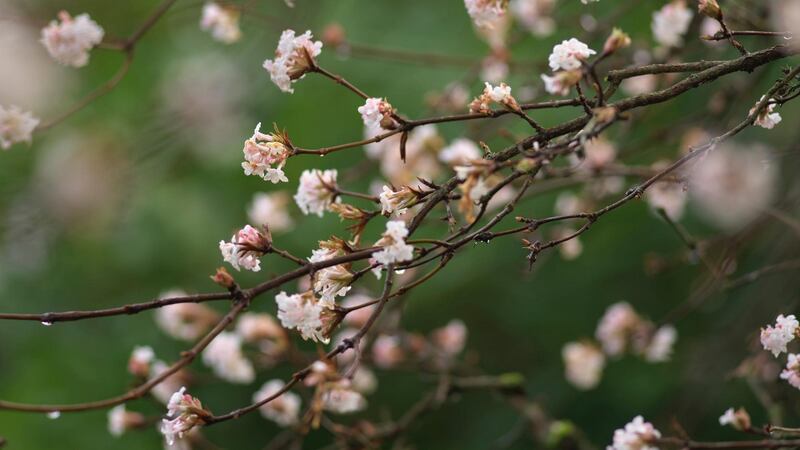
left=264, top=30, right=322, bottom=93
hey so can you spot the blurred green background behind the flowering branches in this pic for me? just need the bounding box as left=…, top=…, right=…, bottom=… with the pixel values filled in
left=0, top=0, right=800, bottom=450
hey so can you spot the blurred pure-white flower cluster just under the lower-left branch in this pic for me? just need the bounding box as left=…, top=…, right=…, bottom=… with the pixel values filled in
left=203, top=332, right=256, bottom=384
